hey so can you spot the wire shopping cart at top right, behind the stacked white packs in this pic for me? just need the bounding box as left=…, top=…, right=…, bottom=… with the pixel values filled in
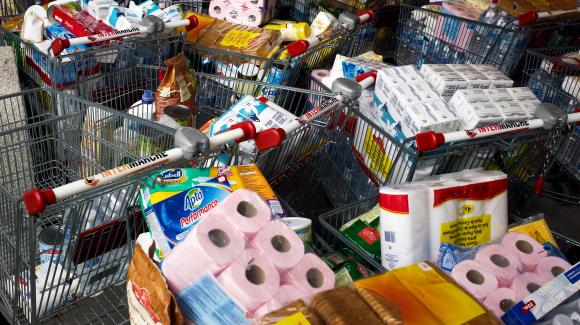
left=396, top=4, right=579, bottom=75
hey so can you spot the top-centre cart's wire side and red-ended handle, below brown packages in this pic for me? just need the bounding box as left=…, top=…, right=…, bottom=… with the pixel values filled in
left=184, top=8, right=373, bottom=90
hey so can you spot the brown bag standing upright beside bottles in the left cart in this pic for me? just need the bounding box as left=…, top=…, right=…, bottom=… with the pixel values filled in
left=154, top=53, right=197, bottom=125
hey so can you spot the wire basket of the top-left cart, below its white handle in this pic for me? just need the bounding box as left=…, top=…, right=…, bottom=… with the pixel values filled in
left=0, top=28, right=183, bottom=89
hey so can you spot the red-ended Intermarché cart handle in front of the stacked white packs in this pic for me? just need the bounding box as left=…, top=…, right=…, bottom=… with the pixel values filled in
left=415, top=109, right=580, bottom=151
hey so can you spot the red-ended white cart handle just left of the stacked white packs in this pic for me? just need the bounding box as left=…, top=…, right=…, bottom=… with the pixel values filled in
left=254, top=71, right=377, bottom=151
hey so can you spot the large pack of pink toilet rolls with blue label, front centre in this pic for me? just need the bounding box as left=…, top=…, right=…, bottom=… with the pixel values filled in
left=161, top=190, right=335, bottom=323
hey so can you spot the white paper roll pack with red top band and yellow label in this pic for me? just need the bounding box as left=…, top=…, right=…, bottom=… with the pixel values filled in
left=379, top=169, right=508, bottom=270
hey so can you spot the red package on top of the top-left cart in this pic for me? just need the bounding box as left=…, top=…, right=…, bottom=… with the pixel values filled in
left=51, top=2, right=115, bottom=37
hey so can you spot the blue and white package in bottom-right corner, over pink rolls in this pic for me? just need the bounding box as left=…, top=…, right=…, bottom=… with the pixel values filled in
left=501, top=263, right=580, bottom=325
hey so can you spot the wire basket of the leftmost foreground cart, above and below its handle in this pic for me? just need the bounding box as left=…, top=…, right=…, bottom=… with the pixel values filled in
left=0, top=89, right=179, bottom=324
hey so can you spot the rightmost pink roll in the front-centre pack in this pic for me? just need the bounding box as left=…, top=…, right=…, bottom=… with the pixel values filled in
left=282, top=253, right=335, bottom=296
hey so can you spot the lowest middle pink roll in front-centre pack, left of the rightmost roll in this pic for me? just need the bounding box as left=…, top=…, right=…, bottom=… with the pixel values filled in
left=217, top=249, right=280, bottom=311
